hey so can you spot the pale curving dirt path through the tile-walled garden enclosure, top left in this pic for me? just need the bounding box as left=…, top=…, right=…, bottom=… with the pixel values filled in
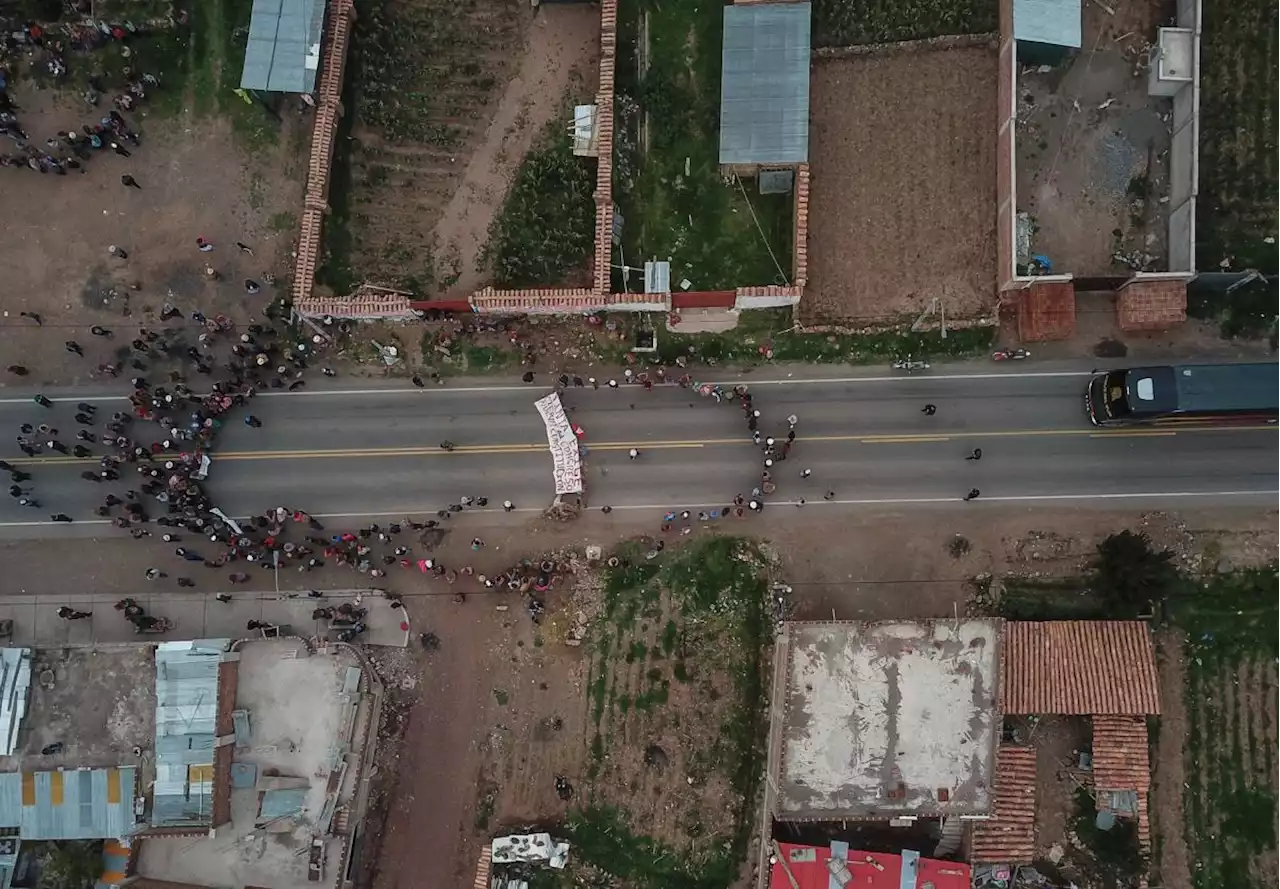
left=435, top=4, right=600, bottom=298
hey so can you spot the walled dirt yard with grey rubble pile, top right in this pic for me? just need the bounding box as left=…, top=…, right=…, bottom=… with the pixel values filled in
left=1015, top=1, right=1172, bottom=278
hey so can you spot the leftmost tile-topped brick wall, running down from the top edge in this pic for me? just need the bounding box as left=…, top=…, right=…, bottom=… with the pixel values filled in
left=293, top=0, right=355, bottom=309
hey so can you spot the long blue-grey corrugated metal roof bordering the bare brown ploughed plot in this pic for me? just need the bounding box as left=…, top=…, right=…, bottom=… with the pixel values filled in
left=719, top=3, right=810, bottom=164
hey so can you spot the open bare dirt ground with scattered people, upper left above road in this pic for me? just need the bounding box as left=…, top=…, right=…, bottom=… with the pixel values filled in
left=0, top=82, right=310, bottom=386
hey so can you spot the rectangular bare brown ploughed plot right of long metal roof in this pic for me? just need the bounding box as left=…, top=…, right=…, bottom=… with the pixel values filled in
left=800, top=47, right=997, bottom=322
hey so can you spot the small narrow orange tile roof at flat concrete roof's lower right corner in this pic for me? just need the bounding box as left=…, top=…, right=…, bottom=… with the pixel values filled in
left=970, top=744, right=1036, bottom=865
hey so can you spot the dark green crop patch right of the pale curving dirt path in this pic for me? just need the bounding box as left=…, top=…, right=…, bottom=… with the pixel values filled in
left=480, top=115, right=595, bottom=288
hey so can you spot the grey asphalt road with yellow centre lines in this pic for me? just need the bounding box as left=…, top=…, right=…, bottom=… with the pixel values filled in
left=0, top=365, right=1280, bottom=537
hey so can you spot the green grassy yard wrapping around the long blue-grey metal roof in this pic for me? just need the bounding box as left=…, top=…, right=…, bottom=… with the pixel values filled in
left=613, top=0, right=792, bottom=292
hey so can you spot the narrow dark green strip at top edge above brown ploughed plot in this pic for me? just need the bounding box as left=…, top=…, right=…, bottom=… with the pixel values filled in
left=813, top=0, right=1000, bottom=46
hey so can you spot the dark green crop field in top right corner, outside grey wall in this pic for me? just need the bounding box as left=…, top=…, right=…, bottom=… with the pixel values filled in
left=1197, top=0, right=1280, bottom=274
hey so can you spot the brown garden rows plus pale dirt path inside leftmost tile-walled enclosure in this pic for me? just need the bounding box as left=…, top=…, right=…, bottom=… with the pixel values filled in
left=337, top=0, right=599, bottom=298
